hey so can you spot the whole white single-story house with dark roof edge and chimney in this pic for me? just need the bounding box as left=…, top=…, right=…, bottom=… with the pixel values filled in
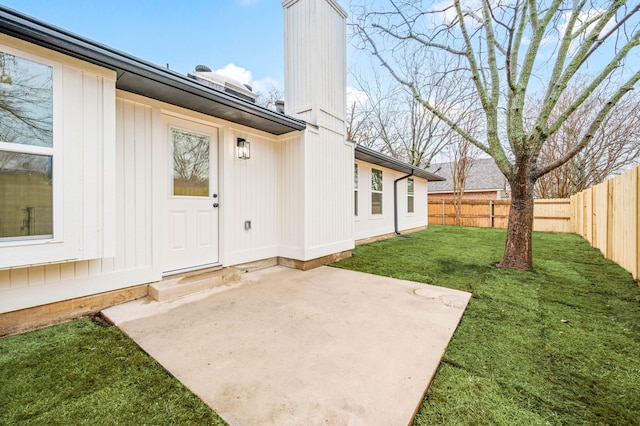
left=0, top=0, right=438, bottom=320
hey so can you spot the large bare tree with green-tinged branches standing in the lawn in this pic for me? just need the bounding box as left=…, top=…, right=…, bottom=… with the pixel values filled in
left=356, top=0, right=640, bottom=270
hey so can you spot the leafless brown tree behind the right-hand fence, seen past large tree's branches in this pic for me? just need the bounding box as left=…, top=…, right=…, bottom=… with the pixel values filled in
left=535, top=90, right=640, bottom=198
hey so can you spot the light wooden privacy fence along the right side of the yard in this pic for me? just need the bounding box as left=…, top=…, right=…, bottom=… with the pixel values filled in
left=571, top=166, right=640, bottom=281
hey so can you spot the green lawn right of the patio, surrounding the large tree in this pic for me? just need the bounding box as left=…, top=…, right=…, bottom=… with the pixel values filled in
left=336, top=225, right=640, bottom=425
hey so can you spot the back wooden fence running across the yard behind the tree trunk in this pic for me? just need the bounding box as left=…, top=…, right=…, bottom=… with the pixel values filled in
left=429, top=198, right=573, bottom=232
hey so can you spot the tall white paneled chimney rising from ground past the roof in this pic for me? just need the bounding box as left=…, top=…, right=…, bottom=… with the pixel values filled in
left=279, top=0, right=353, bottom=260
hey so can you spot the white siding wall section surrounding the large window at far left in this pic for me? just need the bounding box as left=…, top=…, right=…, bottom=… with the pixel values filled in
left=0, top=35, right=129, bottom=312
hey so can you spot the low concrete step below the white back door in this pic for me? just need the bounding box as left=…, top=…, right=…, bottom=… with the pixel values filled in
left=149, top=267, right=242, bottom=301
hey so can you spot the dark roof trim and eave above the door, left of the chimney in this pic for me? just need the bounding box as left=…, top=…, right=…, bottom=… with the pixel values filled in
left=0, top=5, right=306, bottom=135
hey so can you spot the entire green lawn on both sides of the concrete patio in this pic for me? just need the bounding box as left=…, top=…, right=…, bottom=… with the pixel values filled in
left=0, top=225, right=640, bottom=425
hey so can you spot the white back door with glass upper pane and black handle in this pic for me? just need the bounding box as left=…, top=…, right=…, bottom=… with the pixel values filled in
left=163, top=122, right=219, bottom=272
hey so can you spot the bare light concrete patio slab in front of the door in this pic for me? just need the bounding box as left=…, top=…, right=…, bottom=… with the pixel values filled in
left=103, top=267, right=471, bottom=425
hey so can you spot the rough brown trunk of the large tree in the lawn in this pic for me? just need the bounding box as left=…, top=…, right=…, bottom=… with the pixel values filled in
left=498, top=161, right=535, bottom=271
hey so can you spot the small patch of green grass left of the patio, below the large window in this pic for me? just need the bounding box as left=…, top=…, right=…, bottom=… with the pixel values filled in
left=0, top=318, right=226, bottom=425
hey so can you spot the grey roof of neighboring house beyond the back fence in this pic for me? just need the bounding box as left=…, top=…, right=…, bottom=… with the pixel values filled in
left=427, top=158, right=507, bottom=193
